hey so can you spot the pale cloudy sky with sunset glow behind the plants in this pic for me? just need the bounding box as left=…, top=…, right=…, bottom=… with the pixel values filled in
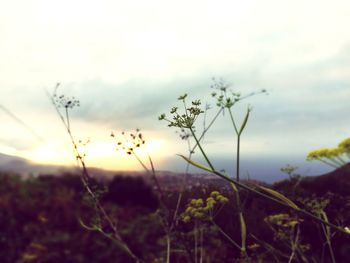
left=0, top=0, right=350, bottom=182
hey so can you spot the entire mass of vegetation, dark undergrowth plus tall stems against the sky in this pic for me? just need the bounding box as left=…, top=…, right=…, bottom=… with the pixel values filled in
left=0, top=80, right=350, bottom=263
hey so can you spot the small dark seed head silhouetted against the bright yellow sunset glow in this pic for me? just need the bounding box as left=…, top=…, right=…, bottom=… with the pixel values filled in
left=111, top=129, right=145, bottom=155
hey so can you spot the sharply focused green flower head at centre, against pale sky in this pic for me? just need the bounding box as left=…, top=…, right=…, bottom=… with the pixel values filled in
left=158, top=94, right=204, bottom=129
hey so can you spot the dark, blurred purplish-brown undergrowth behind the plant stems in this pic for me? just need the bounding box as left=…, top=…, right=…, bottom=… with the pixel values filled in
left=0, top=166, right=350, bottom=263
